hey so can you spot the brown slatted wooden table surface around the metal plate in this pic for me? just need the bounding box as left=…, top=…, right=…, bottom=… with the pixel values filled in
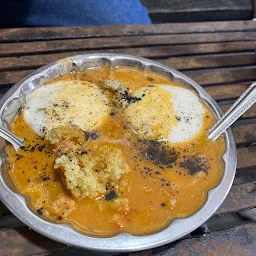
left=0, top=21, right=256, bottom=256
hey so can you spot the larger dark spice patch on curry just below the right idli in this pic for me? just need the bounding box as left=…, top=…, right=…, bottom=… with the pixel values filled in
left=142, top=140, right=179, bottom=168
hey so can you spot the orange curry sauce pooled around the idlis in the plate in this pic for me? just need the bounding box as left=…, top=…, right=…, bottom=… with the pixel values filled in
left=7, top=67, right=225, bottom=236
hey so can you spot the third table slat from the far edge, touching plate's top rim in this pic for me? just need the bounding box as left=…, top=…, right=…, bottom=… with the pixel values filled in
left=0, top=41, right=256, bottom=71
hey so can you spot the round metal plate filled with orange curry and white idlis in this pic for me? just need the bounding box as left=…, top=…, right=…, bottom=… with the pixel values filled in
left=0, top=54, right=236, bottom=252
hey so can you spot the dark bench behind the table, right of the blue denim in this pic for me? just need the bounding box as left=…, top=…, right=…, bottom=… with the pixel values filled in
left=142, top=0, right=253, bottom=23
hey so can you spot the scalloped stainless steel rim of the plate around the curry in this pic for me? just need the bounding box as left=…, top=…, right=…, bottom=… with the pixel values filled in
left=0, top=54, right=237, bottom=252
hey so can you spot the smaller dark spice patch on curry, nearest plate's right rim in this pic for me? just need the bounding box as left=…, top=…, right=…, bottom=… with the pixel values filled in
left=180, top=155, right=209, bottom=175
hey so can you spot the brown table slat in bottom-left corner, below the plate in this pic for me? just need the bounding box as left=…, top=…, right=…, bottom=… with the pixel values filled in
left=0, top=227, right=67, bottom=256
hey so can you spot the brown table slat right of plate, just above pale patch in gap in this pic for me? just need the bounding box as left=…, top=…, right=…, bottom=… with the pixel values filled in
left=216, top=182, right=256, bottom=214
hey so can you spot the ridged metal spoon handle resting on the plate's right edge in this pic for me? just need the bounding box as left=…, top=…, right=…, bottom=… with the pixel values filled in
left=208, top=82, right=256, bottom=140
